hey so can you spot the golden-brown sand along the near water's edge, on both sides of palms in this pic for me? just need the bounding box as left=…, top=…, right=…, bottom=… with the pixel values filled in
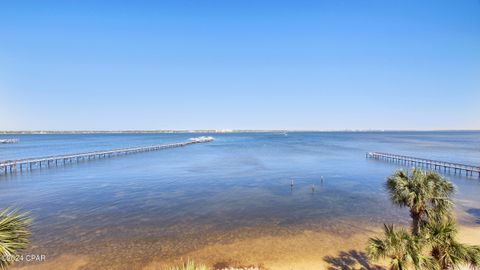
left=13, top=221, right=480, bottom=270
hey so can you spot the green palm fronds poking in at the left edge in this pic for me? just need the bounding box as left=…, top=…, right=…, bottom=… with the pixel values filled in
left=0, top=209, right=31, bottom=269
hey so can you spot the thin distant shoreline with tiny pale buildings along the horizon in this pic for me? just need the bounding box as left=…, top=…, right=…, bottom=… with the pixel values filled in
left=0, top=129, right=480, bottom=135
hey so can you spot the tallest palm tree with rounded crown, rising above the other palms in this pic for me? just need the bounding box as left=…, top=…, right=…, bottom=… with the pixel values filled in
left=386, top=168, right=455, bottom=236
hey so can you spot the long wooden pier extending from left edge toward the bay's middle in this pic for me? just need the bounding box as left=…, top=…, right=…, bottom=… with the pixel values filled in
left=0, top=137, right=214, bottom=175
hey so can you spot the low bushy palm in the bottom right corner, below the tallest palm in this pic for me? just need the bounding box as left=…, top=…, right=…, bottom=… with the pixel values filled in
left=426, top=218, right=480, bottom=270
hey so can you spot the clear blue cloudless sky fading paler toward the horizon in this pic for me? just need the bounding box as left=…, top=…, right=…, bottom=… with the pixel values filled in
left=0, top=0, right=480, bottom=130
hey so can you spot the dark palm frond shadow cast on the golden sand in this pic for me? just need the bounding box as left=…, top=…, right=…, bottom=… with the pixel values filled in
left=323, top=250, right=385, bottom=270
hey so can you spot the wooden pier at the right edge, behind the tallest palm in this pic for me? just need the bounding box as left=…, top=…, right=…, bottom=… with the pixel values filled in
left=366, top=152, right=480, bottom=178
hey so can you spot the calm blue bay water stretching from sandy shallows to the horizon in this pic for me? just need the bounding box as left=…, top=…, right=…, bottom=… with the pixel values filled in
left=0, top=132, right=480, bottom=268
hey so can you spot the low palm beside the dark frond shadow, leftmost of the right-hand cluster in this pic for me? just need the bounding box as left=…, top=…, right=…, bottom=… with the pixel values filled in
left=367, top=224, right=437, bottom=270
